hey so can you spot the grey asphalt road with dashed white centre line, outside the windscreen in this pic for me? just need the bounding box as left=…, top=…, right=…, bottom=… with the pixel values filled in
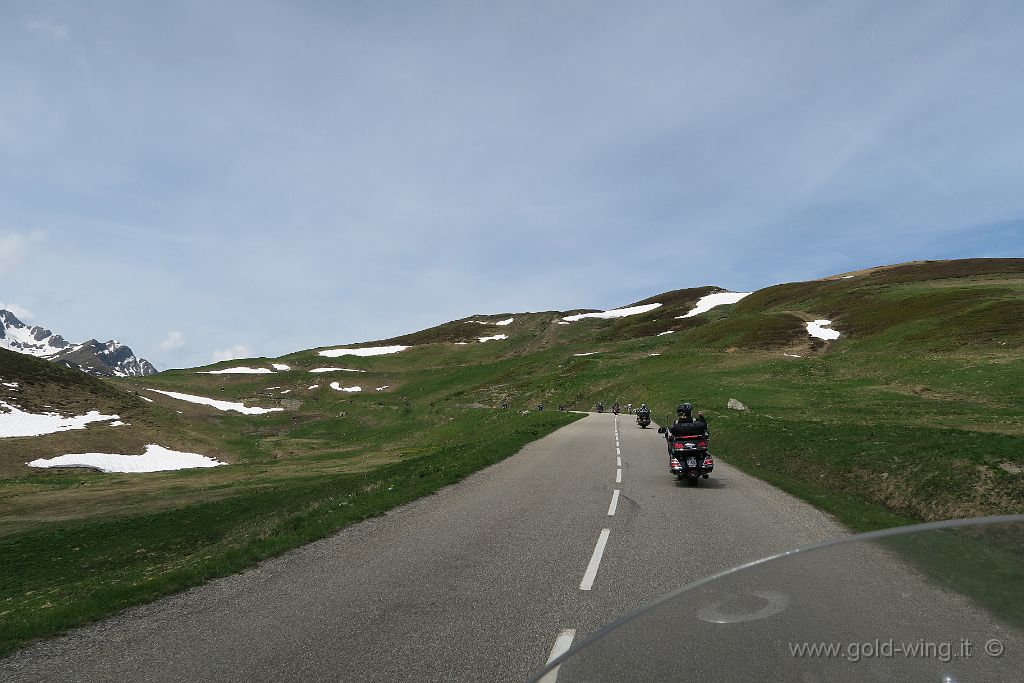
left=0, top=414, right=1015, bottom=681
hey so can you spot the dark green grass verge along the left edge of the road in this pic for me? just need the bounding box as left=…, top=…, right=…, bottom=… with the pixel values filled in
left=0, top=412, right=581, bottom=655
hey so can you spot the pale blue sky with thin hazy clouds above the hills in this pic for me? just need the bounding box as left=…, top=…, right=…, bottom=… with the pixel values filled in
left=0, top=0, right=1024, bottom=369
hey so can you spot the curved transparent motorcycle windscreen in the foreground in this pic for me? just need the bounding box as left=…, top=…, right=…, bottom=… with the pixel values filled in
left=535, top=515, right=1024, bottom=683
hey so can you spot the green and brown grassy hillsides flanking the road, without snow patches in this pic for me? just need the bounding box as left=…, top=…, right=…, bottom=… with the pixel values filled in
left=0, top=259, right=1024, bottom=652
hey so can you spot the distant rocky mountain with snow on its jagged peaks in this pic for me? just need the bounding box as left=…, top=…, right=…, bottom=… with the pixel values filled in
left=0, top=309, right=157, bottom=377
